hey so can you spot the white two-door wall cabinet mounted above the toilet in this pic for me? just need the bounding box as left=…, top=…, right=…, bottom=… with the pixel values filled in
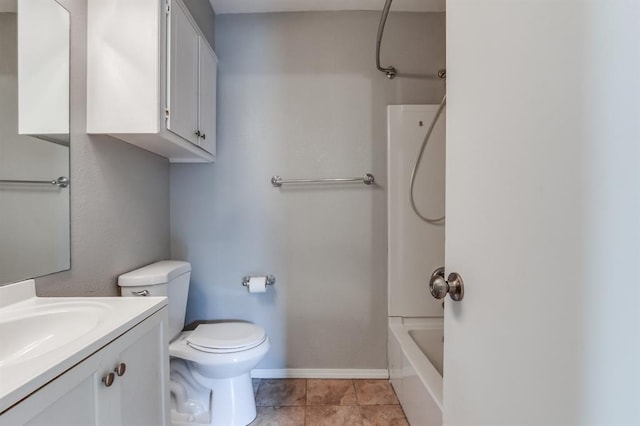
left=87, top=0, right=217, bottom=162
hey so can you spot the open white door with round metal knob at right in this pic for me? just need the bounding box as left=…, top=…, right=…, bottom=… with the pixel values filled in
left=444, top=0, right=640, bottom=425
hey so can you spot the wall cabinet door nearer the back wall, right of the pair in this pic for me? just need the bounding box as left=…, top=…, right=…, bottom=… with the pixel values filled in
left=198, top=41, right=217, bottom=156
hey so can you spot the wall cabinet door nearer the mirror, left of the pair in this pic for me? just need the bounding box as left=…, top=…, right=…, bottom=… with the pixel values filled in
left=167, top=2, right=200, bottom=145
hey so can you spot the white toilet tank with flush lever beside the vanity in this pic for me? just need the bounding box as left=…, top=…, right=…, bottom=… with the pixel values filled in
left=118, top=260, right=191, bottom=340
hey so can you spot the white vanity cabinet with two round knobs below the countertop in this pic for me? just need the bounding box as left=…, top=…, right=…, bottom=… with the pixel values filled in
left=0, top=307, right=169, bottom=426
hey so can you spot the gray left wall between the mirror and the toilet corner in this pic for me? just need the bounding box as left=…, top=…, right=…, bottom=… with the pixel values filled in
left=36, top=0, right=169, bottom=296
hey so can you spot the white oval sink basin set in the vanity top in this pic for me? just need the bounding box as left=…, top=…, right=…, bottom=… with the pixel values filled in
left=0, top=301, right=112, bottom=367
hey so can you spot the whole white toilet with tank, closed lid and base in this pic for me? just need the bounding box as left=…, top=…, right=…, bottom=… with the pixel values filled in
left=118, top=260, right=271, bottom=426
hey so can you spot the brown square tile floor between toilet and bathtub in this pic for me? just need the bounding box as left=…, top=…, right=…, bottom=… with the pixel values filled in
left=251, top=379, right=409, bottom=426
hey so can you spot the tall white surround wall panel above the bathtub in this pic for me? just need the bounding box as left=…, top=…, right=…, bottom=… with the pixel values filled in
left=387, top=105, right=446, bottom=317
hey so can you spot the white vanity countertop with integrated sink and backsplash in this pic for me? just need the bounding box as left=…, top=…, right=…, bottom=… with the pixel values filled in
left=0, top=280, right=167, bottom=413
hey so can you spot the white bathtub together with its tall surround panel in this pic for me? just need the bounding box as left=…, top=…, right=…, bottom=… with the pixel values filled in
left=387, top=105, right=445, bottom=426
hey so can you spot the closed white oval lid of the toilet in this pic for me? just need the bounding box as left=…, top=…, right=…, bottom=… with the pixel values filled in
left=186, top=322, right=267, bottom=352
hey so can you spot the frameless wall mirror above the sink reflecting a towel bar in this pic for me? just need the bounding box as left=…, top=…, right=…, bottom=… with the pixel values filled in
left=0, top=0, right=71, bottom=284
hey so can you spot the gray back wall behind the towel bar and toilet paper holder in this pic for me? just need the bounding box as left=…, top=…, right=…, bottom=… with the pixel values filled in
left=171, top=12, right=445, bottom=368
